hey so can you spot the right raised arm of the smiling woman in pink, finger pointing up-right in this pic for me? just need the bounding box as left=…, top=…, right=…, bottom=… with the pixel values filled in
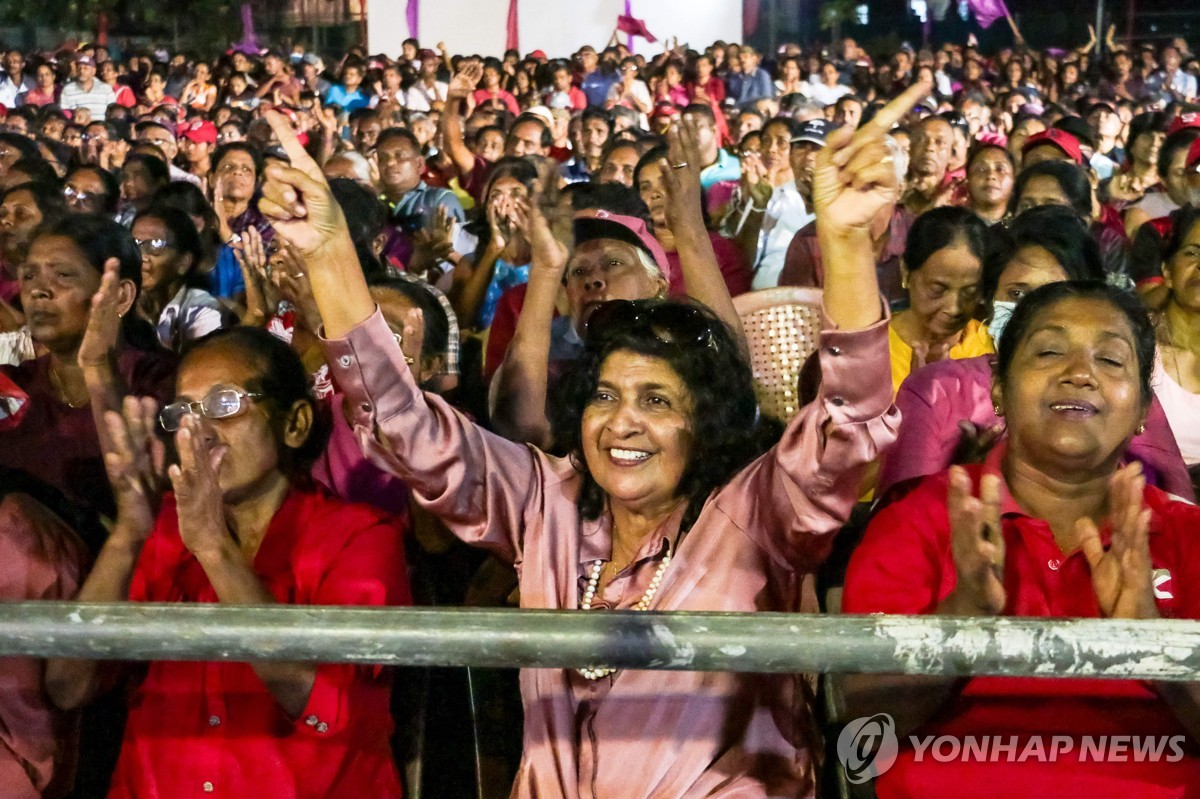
left=727, top=80, right=929, bottom=569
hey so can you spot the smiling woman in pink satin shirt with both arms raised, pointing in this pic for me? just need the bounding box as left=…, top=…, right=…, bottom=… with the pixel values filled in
left=253, top=77, right=928, bottom=799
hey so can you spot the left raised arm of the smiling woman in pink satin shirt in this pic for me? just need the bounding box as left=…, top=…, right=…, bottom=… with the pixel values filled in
left=259, top=112, right=545, bottom=560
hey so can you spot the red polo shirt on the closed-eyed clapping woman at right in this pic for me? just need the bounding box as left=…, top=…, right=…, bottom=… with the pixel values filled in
left=842, top=445, right=1200, bottom=799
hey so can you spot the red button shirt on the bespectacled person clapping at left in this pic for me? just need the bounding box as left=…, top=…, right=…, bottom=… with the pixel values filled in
left=108, top=487, right=412, bottom=799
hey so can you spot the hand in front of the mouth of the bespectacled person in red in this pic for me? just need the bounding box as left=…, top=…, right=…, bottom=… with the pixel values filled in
left=167, top=414, right=233, bottom=558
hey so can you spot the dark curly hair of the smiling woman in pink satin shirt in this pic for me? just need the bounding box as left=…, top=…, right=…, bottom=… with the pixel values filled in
left=552, top=300, right=782, bottom=533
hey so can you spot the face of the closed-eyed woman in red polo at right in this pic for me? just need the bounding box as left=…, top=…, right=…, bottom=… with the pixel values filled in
left=992, top=298, right=1145, bottom=479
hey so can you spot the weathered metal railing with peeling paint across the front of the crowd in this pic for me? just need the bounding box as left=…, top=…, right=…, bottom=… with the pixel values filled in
left=0, top=602, right=1200, bottom=681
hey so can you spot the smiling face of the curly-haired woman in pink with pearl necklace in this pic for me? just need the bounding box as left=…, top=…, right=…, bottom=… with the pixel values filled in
left=582, top=350, right=692, bottom=513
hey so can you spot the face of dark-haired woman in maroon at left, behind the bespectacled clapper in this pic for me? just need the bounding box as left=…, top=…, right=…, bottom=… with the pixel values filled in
left=17, top=235, right=100, bottom=353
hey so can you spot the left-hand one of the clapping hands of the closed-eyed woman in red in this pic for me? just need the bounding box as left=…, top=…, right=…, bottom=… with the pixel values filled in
left=942, top=467, right=1007, bottom=615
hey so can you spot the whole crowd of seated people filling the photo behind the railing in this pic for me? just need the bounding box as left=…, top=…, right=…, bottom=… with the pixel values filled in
left=0, top=21, right=1200, bottom=799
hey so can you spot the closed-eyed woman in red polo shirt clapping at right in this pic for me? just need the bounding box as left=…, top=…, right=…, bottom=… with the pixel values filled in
left=842, top=281, right=1200, bottom=799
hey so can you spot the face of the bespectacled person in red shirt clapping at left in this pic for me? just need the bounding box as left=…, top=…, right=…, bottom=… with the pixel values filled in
left=175, top=344, right=295, bottom=503
